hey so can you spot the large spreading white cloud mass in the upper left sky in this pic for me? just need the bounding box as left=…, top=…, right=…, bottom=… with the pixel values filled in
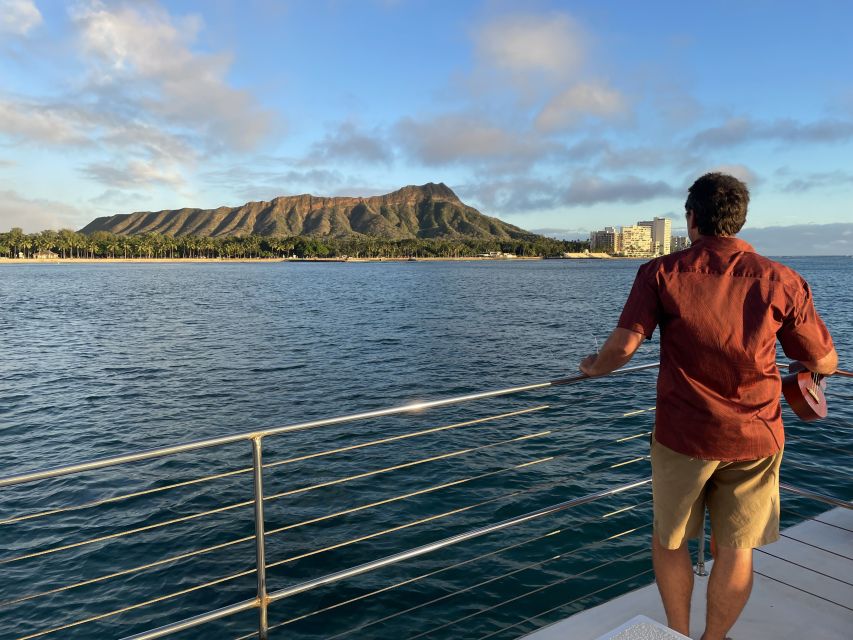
left=0, top=0, right=274, bottom=189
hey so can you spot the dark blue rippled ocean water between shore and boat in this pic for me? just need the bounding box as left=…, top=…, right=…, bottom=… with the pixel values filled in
left=0, top=257, right=853, bottom=639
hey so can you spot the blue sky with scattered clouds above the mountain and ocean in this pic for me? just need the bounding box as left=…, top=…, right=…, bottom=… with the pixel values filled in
left=0, top=0, right=853, bottom=254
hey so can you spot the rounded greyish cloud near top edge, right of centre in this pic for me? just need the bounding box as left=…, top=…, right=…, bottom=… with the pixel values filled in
left=474, top=13, right=586, bottom=80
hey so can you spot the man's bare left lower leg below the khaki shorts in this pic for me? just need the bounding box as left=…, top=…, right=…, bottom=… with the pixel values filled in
left=652, top=534, right=693, bottom=636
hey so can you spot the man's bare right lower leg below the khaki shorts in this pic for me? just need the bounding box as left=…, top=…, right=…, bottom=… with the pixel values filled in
left=700, top=545, right=752, bottom=640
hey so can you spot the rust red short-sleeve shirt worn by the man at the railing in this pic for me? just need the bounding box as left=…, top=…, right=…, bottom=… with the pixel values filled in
left=617, top=236, right=833, bottom=460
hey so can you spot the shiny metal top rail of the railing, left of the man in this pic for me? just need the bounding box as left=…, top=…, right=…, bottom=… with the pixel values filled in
left=0, top=362, right=660, bottom=487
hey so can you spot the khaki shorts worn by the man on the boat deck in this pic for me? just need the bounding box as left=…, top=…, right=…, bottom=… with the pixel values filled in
left=652, top=439, right=782, bottom=549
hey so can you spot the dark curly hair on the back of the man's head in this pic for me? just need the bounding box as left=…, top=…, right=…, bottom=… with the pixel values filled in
left=684, top=173, right=749, bottom=236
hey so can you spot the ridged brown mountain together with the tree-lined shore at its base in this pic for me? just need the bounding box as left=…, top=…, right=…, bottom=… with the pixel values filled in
left=0, top=182, right=587, bottom=260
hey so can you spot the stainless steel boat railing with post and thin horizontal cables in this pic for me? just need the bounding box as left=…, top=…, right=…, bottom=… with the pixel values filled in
left=0, top=363, right=850, bottom=640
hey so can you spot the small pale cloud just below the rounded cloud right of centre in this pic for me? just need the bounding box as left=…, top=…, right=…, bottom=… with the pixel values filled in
left=536, top=82, right=628, bottom=131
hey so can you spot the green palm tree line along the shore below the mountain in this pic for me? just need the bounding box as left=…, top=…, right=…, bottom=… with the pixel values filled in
left=0, top=228, right=589, bottom=259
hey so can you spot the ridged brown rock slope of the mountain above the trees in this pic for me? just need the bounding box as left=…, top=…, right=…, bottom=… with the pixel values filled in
left=81, top=182, right=538, bottom=240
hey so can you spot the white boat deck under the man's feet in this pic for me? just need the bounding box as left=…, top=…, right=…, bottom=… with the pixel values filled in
left=524, top=508, right=853, bottom=640
